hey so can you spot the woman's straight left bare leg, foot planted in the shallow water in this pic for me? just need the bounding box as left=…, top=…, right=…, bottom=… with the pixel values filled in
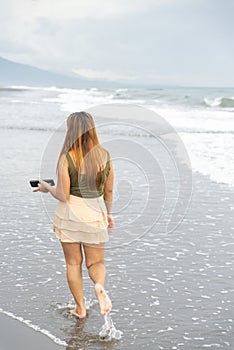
left=61, top=242, right=86, bottom=318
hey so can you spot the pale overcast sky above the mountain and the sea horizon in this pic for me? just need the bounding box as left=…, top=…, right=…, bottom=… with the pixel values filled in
left=0, top=0, right=234, bottom=87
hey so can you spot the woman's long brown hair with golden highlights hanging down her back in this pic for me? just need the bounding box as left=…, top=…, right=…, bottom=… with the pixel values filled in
left=57, top=112, right=109, bottom=190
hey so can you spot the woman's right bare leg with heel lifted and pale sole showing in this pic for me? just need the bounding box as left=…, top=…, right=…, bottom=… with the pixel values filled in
left=84, top=245, right=112, bottom=315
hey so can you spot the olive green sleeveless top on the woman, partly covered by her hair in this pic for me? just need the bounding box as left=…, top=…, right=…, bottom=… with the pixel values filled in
left=66, top=153, right=110, bottom=198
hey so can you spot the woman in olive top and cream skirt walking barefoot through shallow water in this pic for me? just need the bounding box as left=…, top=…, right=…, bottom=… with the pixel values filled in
left=34, top=112, right=114, bottom=318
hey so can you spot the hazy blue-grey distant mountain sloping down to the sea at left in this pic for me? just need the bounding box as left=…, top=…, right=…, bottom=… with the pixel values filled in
left=0, top=57, right=118, bottom=88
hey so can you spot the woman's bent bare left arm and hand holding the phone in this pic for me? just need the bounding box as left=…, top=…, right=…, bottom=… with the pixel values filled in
left=33, top=156, right=70, bottom=202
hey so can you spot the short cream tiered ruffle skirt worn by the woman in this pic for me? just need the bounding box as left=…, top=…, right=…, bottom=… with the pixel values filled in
left=53, top=195, right=109, bottom=244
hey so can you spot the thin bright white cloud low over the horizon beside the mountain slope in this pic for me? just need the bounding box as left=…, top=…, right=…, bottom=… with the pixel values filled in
left=72, top=69, right=137, bottom=81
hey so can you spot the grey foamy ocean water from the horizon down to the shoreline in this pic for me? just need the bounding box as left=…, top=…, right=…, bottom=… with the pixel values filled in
left=0, top=86, right=234, bottom=350
